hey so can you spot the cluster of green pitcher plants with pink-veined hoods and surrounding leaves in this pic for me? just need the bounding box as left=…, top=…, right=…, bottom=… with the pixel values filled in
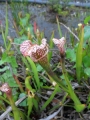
left=0, top=2, right=90, bottom=120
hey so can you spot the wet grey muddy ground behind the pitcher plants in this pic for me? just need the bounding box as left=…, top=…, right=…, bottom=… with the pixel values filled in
left=0, top=3, right=89, bottom=44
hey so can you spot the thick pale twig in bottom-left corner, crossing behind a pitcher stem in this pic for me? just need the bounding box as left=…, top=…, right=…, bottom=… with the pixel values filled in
left=0, top=96, right=27, bottom=120
